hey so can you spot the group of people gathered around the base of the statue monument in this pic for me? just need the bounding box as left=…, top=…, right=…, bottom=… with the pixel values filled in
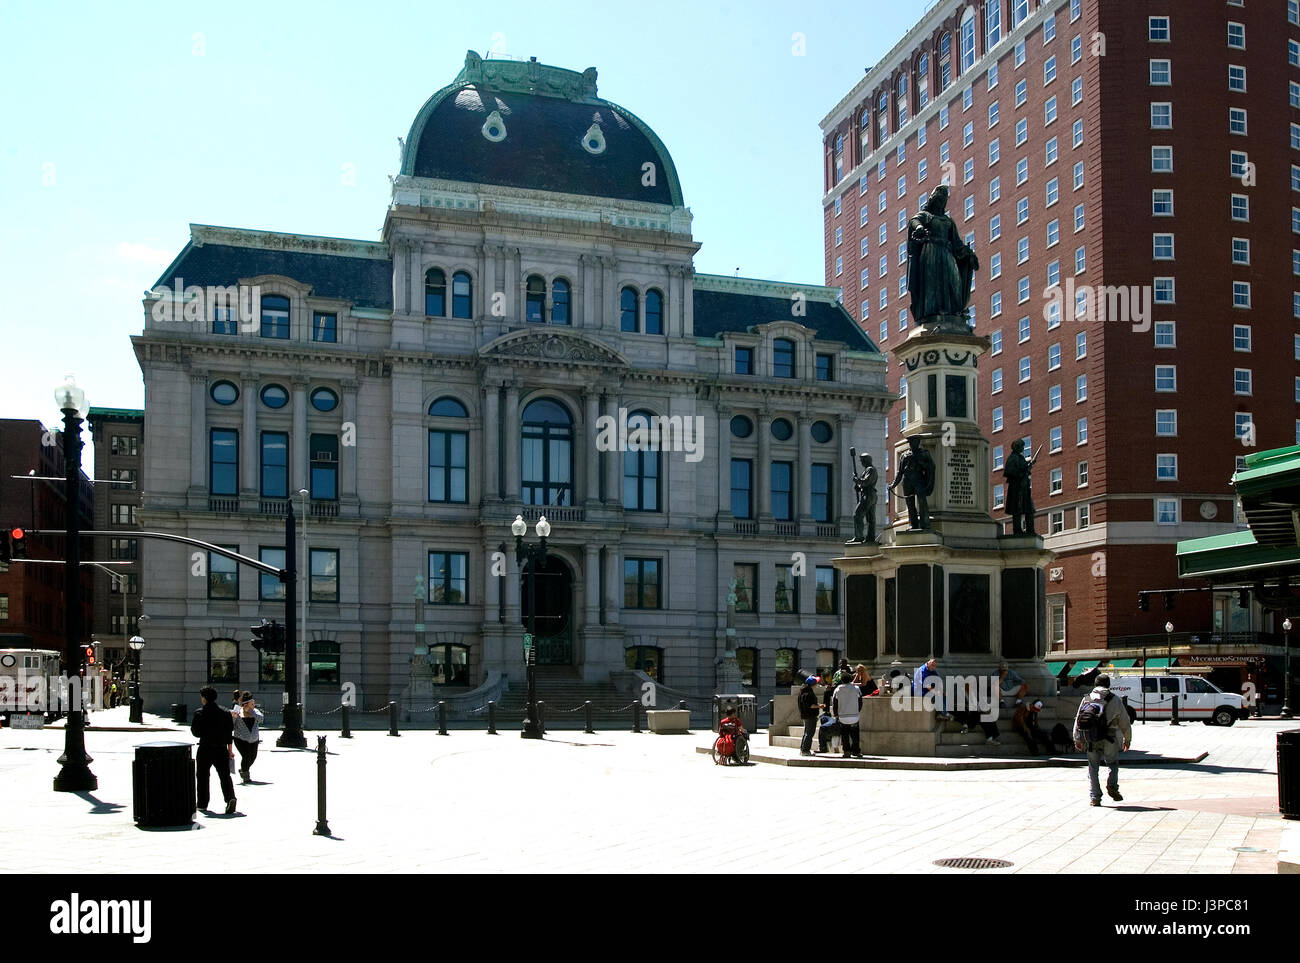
left=798, top=659, right=1060, bottom=759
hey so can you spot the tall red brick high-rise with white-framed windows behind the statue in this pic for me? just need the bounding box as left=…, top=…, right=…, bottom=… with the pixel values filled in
left=822, top=0, right=1300, bottom=650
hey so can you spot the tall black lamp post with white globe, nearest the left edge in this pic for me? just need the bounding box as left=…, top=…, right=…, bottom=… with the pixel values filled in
left=55, top=374, right=99, bottom=793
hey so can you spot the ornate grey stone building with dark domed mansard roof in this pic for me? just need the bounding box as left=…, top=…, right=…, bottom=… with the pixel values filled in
left=133, top=52, right=893, bottom=708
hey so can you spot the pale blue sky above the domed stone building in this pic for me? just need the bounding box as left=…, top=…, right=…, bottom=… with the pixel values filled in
left=0, top=0, right=927, bottom=424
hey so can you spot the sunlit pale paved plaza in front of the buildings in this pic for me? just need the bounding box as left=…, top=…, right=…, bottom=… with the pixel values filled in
left=0, top=708, right=1295, bottom=873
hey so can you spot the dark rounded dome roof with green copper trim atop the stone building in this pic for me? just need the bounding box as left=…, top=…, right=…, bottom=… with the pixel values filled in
left=402, top=51, right=684, bottom=207
